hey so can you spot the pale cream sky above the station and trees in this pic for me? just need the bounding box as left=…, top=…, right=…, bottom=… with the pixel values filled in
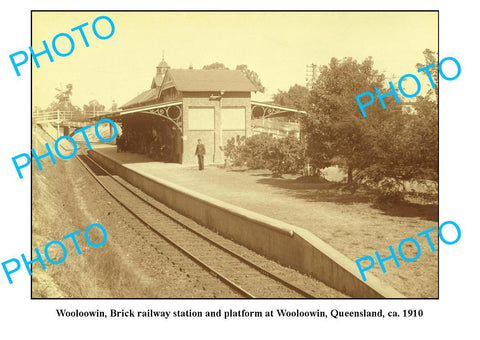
left=31, top=12, right=438, bottom=109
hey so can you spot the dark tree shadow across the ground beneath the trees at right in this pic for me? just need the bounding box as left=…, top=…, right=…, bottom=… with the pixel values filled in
left=256, top=174, right=438, bottom=221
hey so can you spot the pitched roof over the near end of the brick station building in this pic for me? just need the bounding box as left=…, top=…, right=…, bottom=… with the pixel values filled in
left=165, top=69, right=258, bottom=92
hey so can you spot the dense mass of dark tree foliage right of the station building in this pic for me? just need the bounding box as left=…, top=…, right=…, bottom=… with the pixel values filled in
left=303, top=50, right=438, bottom=196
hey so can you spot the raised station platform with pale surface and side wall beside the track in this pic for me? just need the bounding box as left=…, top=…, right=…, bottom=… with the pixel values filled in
left=89, top=145, right=404, bottom=298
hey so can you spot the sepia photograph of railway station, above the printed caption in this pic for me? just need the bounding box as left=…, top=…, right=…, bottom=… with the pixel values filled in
left=31, top=10, right=438, bottom=299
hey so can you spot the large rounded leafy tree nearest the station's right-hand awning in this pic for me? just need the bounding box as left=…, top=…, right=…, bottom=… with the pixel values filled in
left=303, top=57, right=393, bottom=192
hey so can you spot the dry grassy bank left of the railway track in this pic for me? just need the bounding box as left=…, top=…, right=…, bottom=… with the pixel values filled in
left=32, top=127, right=158, bottom=298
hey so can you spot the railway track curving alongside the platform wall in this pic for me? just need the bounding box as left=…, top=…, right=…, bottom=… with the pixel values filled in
left=77, top=155, right=344, bottom=298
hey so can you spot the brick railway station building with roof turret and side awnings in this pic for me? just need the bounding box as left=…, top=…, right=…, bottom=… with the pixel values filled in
left=108, top=59, right=302, bottom=164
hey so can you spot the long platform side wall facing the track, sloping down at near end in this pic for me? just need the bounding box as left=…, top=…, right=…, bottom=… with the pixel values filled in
left=89, top=150, right=404, bottom=298
